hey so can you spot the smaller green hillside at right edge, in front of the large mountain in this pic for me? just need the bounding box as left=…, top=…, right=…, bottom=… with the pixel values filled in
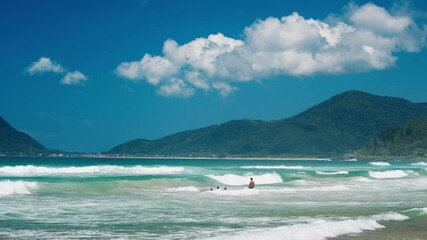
left=358, top=117, right=427, bottom=157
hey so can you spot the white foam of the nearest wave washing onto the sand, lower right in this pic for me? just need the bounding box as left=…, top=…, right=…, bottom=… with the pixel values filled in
left=212, top=213, right=408, bottom=240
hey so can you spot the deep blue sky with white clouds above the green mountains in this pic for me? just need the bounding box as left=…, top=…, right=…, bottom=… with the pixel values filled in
left=0, top=0, right=427, bottom=152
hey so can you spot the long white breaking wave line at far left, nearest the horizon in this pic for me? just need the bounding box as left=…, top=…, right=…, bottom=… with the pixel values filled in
left=0, top=165, right=184, bottom=176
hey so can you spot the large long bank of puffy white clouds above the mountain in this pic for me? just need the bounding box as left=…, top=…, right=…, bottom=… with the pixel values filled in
left=116, top=3, right=427, bottom=97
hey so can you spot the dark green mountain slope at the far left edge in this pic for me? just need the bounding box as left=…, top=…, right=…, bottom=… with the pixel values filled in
left=0, top=117, right=47, bottom=155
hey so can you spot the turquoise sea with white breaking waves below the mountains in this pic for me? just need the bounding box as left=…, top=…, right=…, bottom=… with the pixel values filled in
left=0, top=158, right=427, bottom=239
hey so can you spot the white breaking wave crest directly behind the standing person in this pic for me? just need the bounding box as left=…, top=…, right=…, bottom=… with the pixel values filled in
left=207, top=173, right=283, bottom=186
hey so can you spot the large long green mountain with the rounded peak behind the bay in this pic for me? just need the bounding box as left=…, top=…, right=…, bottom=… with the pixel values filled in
left=108, top=91, right=427, bottom=157
